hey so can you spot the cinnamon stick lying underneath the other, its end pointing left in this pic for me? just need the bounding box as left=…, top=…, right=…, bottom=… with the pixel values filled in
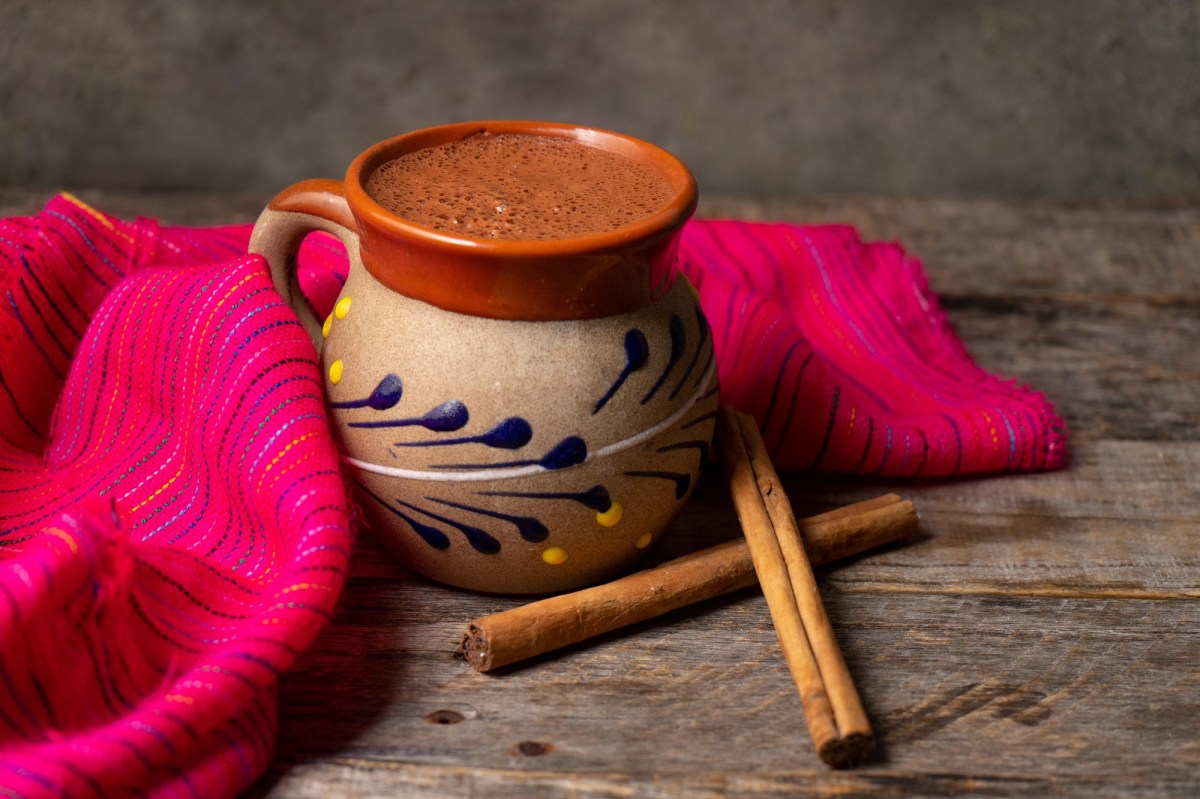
left=461, top=494, right=917, bottom=672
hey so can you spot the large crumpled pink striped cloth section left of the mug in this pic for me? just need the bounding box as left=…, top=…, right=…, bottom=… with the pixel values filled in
left=0, top=198, right=352, bottom=799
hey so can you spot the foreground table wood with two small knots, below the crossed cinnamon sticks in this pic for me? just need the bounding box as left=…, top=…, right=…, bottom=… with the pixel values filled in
left=250, top=587, right=1200, bottom=798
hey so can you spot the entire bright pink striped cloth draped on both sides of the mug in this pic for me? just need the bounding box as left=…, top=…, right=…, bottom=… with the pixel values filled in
left=0, top=196, right=1064, bottom=798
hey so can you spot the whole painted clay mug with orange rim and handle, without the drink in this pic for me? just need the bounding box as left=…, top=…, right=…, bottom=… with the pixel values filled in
left=244, top=121, right=716, bottom=594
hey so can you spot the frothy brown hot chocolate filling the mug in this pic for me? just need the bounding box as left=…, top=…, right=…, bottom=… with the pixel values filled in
left=366, top=133, right=676, bottom=241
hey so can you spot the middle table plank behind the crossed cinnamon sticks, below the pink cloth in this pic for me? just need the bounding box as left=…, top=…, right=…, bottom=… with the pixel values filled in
left=340, top=441, right=1200, bottom=599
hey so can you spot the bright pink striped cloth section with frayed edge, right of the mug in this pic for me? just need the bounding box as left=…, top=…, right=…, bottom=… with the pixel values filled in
left=680, top=221, right=1066, bottom=477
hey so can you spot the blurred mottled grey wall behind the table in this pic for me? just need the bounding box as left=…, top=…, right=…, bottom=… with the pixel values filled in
left=0, top=0, right=1200, bottom=196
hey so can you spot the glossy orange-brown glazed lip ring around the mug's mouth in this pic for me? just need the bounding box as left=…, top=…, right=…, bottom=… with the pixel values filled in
left=344, top=120, right=697, bottom=259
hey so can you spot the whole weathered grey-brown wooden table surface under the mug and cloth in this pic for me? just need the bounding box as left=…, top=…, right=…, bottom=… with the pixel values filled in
left=0, top=190, right=1200, bottom=799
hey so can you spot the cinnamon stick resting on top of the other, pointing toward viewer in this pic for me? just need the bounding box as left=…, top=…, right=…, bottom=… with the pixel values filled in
left=716, top=407, right=874, bottom=768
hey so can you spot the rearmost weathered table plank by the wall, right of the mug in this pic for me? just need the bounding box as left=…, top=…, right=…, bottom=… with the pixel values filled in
left=700, top=195, right=1200, bottom=300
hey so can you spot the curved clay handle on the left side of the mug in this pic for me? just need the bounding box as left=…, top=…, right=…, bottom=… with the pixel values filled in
left=250, top=178, right=359, bottom=353
